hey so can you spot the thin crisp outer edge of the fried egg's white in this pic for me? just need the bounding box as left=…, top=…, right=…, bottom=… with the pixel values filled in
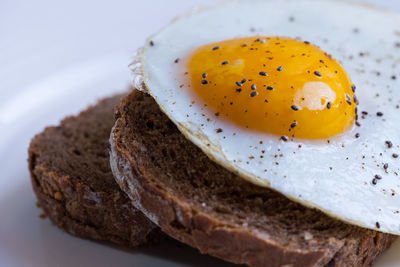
left=135, top=0, right=400, bottom=235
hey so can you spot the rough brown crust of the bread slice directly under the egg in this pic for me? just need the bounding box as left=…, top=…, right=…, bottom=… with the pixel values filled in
left=110, top=92, right=395, bottom=266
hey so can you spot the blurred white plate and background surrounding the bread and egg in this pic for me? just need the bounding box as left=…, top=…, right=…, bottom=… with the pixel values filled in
left=0, top=0, right=400, bottom=266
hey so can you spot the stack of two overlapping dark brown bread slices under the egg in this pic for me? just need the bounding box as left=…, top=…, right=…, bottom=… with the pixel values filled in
left=29, top=89, right=395, bottom=266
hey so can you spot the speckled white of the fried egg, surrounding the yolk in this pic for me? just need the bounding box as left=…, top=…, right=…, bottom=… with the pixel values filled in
left=132, top=0, right=400, bottom=235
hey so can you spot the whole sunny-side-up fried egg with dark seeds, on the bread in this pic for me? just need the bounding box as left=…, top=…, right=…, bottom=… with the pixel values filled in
left=131, top=0, right=400, bottom=235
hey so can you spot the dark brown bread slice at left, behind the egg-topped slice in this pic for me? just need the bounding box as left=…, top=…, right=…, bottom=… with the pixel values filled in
left=29, top=95, right=160, bottom=247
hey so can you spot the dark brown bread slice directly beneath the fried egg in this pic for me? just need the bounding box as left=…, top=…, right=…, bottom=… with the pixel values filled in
left=110, top=91, right=395, bottom=267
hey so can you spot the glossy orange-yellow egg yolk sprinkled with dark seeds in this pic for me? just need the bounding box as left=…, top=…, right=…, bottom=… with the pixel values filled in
left=188, top=37, right=358, bottom=139
